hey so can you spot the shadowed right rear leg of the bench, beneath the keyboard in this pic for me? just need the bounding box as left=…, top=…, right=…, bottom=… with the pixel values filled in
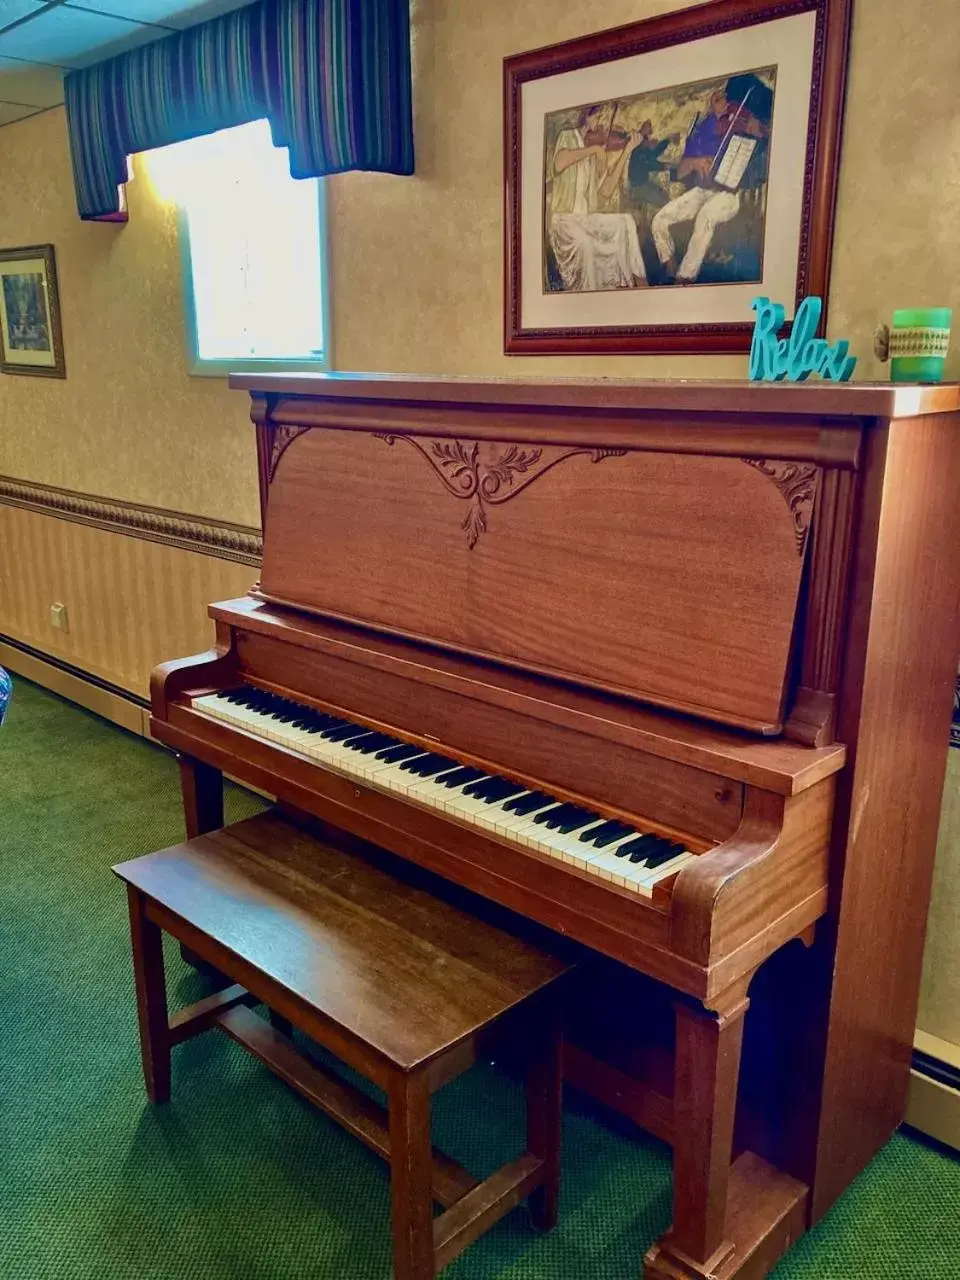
left=526, top=1000, right=563, bottom=1231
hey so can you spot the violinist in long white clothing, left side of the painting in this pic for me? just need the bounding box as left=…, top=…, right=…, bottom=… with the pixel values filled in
left=547, top=104, right=646, bottom=292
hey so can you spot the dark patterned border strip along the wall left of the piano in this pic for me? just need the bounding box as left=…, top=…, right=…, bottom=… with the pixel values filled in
left=0, top=475, right=262, bottom=567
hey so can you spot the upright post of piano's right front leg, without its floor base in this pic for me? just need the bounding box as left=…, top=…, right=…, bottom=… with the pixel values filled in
left=644, top=982, right=749, bottom=1280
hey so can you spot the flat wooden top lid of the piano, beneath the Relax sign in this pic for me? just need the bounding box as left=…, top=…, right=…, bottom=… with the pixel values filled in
left=230, top=372, right=960, bottom=425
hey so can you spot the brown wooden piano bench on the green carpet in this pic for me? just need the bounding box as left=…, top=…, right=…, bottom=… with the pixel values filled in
left=114, top=813, right=570, bottom=1280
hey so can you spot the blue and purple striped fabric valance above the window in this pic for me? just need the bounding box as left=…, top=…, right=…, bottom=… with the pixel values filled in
left=65, top=0, right=413, bottom=219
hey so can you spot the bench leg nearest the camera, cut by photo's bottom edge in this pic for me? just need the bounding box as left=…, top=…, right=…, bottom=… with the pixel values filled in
left=389, top=1071, right=436, bottom=1280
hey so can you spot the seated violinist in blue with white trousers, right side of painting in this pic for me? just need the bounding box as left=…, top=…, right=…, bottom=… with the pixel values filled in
left=652, top=74, right=773, bottom=284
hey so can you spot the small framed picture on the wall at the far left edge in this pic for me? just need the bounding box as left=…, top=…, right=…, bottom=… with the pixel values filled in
left=0, top=244, right=67, bottom=378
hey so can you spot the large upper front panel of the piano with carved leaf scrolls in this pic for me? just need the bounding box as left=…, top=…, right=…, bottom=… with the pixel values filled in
left=261, top=428, right=819, bottom=732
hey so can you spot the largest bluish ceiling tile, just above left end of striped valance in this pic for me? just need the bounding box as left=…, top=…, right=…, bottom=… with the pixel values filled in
left=0, top=5, right=157, bottom=67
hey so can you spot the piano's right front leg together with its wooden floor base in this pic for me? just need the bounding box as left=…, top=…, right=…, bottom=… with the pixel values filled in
left=644, top=975, right=808, bottom=1280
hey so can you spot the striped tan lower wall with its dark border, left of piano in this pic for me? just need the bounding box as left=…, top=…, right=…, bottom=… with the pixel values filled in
left=0, top=476, right=260, bottom=700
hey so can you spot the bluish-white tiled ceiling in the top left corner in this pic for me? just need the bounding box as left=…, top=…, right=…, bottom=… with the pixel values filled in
left=0, top=0, right=257, bottom=125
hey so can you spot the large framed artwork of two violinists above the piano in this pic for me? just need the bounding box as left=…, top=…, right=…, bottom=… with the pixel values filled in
left=504, top=0, right=852, bottom=355
